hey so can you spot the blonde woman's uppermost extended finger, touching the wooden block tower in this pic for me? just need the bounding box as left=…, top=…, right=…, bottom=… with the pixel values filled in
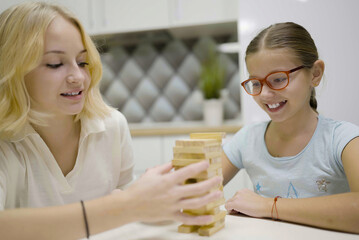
left=171, top=161, right=209, bottom=183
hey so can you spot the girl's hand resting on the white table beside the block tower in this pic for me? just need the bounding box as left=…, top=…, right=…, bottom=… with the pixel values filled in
left=225, top=189, right=273, bottom=217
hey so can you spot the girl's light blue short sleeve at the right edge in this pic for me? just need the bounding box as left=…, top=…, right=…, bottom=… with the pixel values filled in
left=333, top=122, right=359, bottom=170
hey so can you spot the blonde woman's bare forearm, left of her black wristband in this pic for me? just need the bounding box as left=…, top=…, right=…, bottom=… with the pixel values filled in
left=0, top=203, right=86, bottom=240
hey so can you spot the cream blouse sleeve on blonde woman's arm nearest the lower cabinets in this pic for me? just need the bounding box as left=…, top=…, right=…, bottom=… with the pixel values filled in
left=117, top=113, right=134, bottom=188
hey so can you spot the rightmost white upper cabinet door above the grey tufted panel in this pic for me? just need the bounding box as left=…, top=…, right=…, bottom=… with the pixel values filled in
left=169, top=0, right=238, bottom=26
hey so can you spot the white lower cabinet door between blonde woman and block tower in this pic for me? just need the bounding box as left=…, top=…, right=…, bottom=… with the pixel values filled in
left=132, top=136, right=162, bottom=176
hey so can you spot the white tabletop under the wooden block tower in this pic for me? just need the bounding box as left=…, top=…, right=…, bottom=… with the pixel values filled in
left=91, top=215, right=359, bottom=240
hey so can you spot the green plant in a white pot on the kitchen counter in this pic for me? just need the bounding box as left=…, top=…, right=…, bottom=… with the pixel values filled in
left=199, top=48, right=225, bottom=126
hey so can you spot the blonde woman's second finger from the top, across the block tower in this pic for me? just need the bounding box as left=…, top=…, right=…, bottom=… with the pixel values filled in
left=177, top=176, right=222, bottom=198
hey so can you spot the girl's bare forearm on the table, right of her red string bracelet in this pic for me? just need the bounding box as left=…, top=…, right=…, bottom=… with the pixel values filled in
left=266, top=192, right=359, bottom=233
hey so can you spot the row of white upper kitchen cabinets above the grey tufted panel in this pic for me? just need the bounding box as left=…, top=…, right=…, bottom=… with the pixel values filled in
left=0, top=0, right=238, bottom=35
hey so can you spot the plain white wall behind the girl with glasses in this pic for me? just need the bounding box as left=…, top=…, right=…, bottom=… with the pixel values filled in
left=238, top=0, right=359, bottom=125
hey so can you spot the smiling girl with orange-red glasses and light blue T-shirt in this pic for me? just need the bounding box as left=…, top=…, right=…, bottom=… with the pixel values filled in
left=222, top=22, right=359, bottom=233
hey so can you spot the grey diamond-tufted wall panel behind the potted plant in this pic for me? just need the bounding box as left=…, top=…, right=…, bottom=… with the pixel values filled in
left=100, top=37, right=240, bottom=123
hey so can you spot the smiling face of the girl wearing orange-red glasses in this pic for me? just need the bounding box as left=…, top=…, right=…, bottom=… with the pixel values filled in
left=247, top=48, right=311, bottom=122
